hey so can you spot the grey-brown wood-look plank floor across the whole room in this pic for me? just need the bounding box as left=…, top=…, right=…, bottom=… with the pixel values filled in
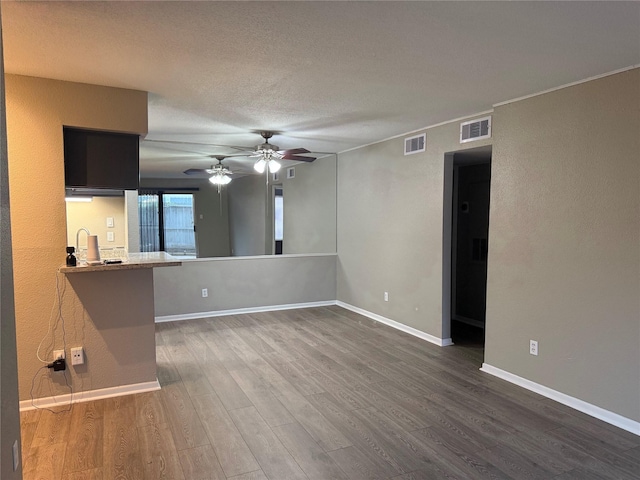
left=21, top=307, right=640, bottom=480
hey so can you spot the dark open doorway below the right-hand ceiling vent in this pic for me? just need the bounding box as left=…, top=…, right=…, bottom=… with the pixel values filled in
left=443, top=147, right=491, bottom=348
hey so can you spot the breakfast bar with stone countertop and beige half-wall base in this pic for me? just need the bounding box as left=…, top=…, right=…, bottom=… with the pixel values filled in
left=50, top=252, right=182, bottom=401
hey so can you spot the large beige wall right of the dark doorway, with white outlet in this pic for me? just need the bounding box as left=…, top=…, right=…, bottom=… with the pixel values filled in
left=485, top=69, right=640, bottom=421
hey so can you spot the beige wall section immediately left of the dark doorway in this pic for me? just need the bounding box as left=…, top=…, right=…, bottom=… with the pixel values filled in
left=337, top=118, right=488, bottom=338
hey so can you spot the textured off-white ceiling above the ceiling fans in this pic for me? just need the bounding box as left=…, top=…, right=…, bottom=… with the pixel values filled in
left=1, top=1, right=640, bottom=177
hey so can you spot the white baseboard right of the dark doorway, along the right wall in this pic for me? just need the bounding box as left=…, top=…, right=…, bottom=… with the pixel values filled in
left=480, top=363, right=640, bottom=436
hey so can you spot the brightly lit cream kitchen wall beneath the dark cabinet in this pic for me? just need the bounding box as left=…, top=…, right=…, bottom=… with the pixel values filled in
left=66, top=196, right=127, bottom=250
